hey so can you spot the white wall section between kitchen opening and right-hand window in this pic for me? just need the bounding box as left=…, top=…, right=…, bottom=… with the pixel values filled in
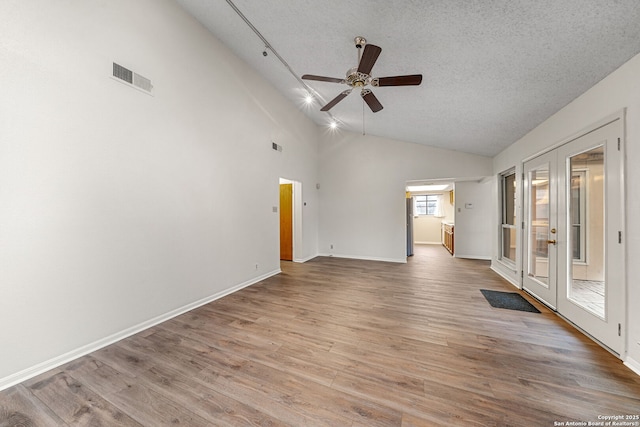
left=453, top=179, right=495, bottom=260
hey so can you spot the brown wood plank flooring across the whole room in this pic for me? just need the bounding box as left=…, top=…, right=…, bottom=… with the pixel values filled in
left=0, top=245, right=640, bottom=427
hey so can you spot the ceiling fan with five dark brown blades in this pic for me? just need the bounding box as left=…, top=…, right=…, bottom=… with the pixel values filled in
left=302, top=37, right=422, bottom=113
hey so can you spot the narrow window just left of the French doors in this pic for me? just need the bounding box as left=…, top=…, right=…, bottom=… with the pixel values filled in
left=500, top=170, right=518, bottom=265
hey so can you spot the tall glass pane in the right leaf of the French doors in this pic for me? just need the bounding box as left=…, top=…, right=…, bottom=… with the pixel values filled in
left=567, top=146, right=606, bottom=318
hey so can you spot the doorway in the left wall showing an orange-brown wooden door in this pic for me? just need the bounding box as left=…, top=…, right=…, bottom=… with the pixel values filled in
left=279, top=178, right=302, bottom=262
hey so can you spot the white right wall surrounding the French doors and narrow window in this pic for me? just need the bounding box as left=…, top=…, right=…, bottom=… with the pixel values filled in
left=492, top=55, right=640, bottom=373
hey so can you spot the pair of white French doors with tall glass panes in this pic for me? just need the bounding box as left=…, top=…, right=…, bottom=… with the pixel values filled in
left=523, top=120, right=625, bottom=355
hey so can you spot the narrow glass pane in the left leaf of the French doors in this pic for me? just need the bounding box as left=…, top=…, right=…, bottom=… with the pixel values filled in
left=528, top=165, right=549, bottom=285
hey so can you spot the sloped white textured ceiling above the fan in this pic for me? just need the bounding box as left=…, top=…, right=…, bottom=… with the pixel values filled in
left=178, top=0, right=640, bottom=156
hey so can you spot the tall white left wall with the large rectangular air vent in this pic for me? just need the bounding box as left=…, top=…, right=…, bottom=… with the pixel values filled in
left=0, top=0, right=319, bottom=388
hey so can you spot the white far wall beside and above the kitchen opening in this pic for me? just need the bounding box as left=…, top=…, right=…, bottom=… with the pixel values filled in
left=319, top=132, right=491, bottom=262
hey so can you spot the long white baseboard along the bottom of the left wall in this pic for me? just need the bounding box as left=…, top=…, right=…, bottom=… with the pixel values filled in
left=0, top=268, right=281, bottom=391
